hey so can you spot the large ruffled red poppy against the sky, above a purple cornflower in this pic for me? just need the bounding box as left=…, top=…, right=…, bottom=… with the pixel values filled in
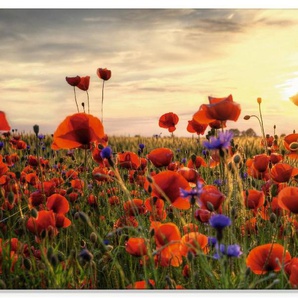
left=193, top=95, right=241, bottom=124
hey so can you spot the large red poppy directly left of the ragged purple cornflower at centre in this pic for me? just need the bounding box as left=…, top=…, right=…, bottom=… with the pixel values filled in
left=144, top=171, right=190, bottom=209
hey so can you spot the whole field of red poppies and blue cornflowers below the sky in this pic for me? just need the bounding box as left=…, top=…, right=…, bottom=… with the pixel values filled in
left=0, top=68, right=298, bottom=290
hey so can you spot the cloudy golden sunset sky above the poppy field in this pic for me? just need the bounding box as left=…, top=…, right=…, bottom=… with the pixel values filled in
left=0, top=3, right=298, bottom=137
